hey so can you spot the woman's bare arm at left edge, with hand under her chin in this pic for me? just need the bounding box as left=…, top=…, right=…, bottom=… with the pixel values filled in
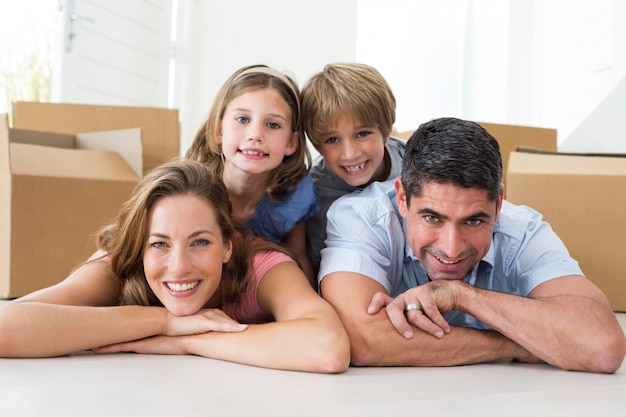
left=0, top=255, right=244, bottom=357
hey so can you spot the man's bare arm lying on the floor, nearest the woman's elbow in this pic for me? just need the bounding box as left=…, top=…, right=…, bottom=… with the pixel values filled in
left=321, top=272, right=536, bottom=366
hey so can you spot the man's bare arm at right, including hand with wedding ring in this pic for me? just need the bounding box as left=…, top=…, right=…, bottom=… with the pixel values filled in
left=380, top=276, right=626, bottom=373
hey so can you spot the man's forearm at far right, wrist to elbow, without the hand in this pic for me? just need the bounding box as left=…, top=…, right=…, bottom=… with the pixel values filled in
left=457, top=282, right=624, bottom=373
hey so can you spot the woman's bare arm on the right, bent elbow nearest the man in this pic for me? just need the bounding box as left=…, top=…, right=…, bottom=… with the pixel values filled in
left=98, top=262, right=349, bottom=373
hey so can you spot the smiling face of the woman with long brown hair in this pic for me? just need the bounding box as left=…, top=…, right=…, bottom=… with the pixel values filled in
left=143, top=195, right=232, bottom=316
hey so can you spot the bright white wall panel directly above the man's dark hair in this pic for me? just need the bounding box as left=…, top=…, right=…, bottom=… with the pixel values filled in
left=357, top=0, right=467, bottom=131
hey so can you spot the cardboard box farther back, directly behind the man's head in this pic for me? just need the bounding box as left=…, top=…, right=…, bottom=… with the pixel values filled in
left=398, top=122, right=557, bottom=185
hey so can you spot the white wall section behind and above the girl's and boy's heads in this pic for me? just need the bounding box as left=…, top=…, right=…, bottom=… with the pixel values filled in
left=178, top=0, right=356, bottom=153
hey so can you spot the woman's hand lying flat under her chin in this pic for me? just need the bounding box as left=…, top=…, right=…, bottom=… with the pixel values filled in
left=163, top=308, right=248, bottom=336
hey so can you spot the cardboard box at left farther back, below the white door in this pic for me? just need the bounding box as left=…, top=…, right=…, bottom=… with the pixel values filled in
left=13, top=101, right=180, bottom=173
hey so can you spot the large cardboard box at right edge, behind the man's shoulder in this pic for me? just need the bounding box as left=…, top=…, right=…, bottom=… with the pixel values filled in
left=507, top=152, right=626, bottom=312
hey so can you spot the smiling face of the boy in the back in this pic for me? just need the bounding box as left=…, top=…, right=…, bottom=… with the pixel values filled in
left=321, top=115, right=389, bottom=187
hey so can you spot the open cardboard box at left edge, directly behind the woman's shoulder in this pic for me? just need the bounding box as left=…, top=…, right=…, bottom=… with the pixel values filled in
left=0, top=115, right=142, bottom=298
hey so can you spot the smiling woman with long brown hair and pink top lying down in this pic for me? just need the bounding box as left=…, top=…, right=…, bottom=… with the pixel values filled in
left=0, top=160, right=349, bottom=373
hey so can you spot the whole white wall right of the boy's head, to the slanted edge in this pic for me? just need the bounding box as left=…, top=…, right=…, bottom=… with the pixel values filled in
left=357, top=0, right=626, bottom=150
